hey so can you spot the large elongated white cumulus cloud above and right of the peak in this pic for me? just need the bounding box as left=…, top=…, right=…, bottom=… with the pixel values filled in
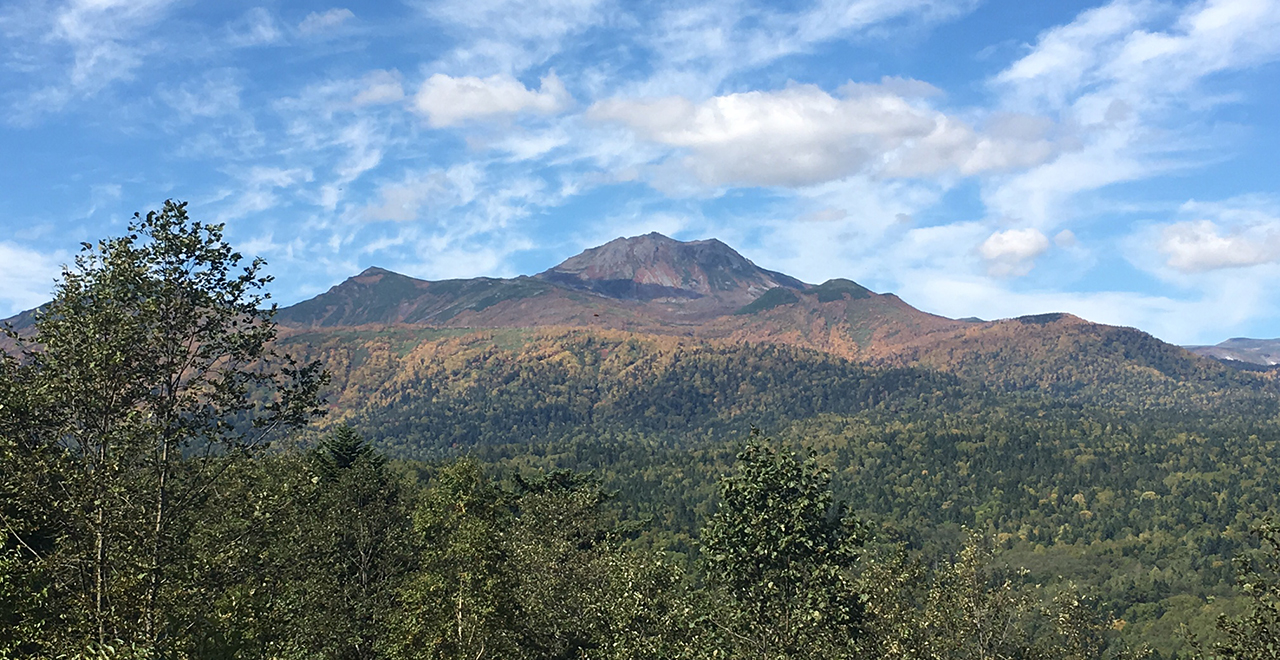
left=588, top=79, right=1053, bottom=187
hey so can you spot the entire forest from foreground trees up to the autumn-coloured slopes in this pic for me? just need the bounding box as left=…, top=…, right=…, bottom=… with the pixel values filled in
left=0, top=202, right=1280, bottom=660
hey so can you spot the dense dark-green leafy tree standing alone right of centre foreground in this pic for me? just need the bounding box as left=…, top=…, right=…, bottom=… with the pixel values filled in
left=703, top=431, right=867, bottom=660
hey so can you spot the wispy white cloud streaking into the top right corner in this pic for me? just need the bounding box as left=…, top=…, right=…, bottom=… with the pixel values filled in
left=984, top=0, right=1280, bottom=228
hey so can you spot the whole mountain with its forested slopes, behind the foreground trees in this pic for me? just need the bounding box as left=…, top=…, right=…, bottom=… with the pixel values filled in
left=10, top=234, right=1280, bottom=652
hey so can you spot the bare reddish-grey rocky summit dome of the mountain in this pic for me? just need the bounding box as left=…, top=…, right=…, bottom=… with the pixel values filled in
left=538, top=232, right=806, bottom=302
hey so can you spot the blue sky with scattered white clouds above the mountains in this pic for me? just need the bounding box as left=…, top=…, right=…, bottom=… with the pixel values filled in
left=0, top=0, right=1280, bottom=343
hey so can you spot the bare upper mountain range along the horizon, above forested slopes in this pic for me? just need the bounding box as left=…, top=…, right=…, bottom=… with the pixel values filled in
left=7, top=233, right=1239, bottom=370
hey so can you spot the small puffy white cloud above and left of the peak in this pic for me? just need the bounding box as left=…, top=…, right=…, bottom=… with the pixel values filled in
left=413, top=72, right=571, bottom=128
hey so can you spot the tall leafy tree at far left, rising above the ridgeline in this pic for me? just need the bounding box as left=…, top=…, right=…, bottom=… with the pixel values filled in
left=0, top=201, right=324, bottom=651
